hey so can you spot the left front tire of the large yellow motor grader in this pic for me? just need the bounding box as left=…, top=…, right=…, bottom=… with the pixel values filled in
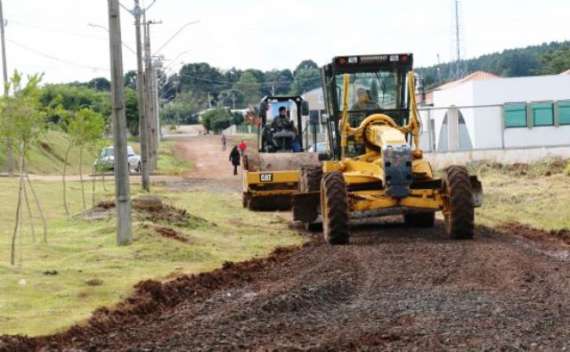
left=321, top=172, right=350, bottom=245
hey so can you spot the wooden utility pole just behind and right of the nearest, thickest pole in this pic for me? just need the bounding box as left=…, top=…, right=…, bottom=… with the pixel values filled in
left=133, top=0, right=150, bottom=192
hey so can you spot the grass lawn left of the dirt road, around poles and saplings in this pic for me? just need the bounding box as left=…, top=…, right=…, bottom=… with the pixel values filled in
left=0, top=179, right=303, bottom=335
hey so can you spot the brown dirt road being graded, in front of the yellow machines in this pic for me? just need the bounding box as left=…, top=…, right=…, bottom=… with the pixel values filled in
left=0, top=136, right=570, bottom=351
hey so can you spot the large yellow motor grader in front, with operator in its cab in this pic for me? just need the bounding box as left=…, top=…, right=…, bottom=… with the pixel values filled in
left=293, top=54, right=482, bottom=244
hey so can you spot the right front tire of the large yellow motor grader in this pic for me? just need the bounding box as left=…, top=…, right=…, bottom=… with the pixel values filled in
left=443, top=166, right=475, bottom=240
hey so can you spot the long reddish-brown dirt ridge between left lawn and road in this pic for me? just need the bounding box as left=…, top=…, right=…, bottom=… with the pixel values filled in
left=0, top=244, right=310, bottom=352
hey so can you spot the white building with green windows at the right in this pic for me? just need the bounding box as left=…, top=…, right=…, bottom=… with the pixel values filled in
left=421, top=72, right=570, bottom=152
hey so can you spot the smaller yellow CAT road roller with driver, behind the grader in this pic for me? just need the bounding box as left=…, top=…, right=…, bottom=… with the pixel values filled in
left=243, top=96, right=320, bottom=211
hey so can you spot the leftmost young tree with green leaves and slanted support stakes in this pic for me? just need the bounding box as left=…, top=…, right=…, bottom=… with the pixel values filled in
left=0, top=72, right=47, bottom=265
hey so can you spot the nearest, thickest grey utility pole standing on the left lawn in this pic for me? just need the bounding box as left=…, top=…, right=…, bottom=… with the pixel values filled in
left=108, top=0, right=132, bottom=246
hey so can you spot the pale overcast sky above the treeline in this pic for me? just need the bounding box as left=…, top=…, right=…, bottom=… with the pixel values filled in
left=3, top=0, right=570, bottom=82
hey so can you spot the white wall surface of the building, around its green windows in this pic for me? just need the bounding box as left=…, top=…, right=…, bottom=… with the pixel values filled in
left=432, top=75, right=570, bottom=149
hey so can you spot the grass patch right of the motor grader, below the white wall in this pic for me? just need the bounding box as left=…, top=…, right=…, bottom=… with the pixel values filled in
left=475, top=162, right=570, bottom=230
